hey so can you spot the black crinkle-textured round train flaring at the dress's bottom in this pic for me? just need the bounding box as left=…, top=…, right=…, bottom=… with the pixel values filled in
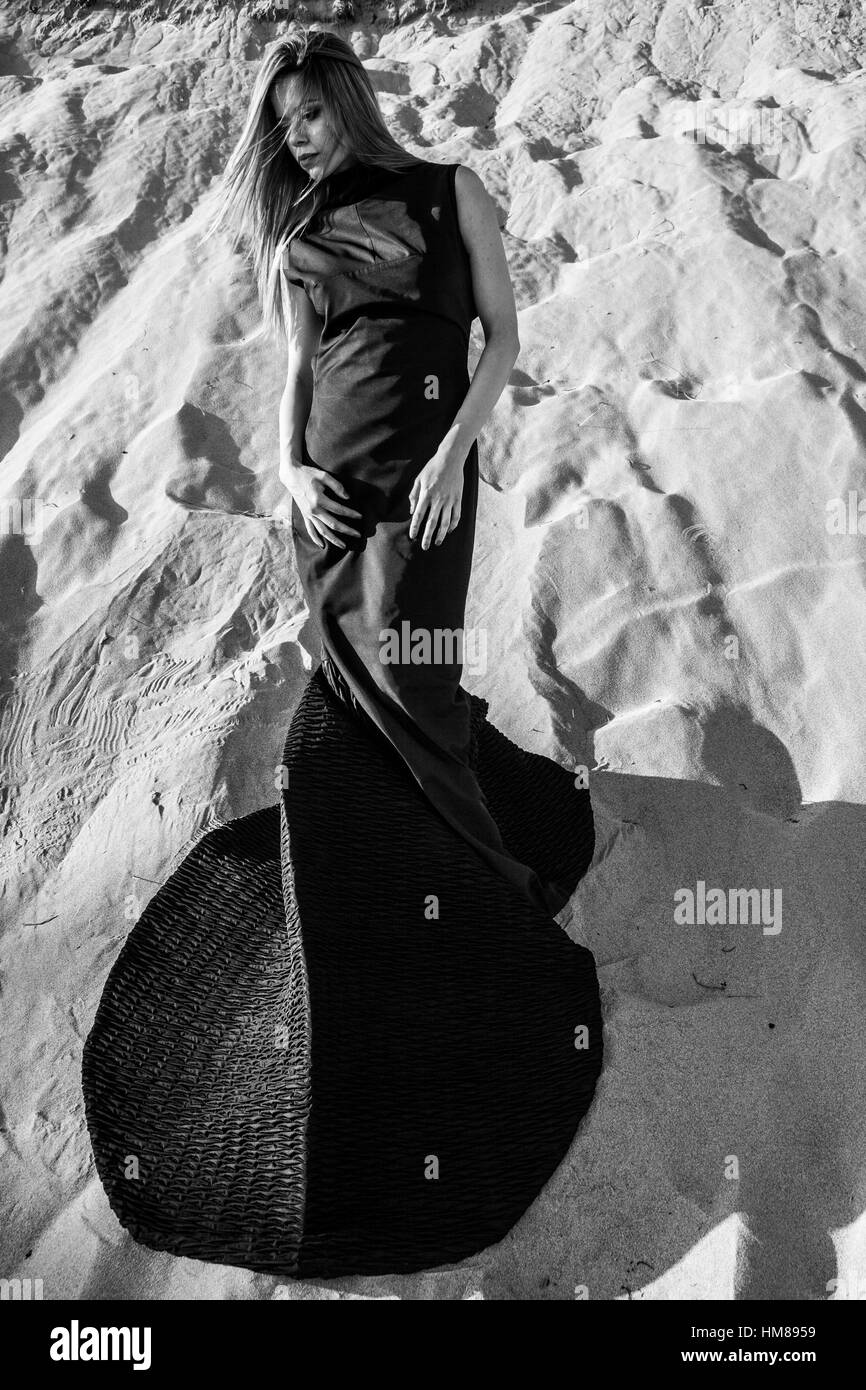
left=82, top=667, right=602, bottom=1279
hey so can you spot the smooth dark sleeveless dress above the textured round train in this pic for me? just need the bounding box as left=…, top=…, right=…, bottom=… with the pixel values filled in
left=284, top=160, right=570, bottom=913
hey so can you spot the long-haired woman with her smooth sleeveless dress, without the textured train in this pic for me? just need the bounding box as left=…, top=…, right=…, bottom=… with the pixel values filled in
left=244, top=32, right=570, bottom=913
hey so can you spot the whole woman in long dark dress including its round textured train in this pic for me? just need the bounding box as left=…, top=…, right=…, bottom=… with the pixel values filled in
left=85, top=31, right=602, bottom=1277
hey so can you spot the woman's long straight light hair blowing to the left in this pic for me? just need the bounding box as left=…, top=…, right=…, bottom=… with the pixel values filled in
left=202, top=28, right=420, bottom=339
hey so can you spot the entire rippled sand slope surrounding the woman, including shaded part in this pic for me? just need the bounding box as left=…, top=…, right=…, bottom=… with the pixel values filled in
left=0, top=0, right=866, bottom=1300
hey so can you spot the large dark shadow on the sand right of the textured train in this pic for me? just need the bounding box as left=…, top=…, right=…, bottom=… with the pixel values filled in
left=478, top=683, right=866, bottom=1300
